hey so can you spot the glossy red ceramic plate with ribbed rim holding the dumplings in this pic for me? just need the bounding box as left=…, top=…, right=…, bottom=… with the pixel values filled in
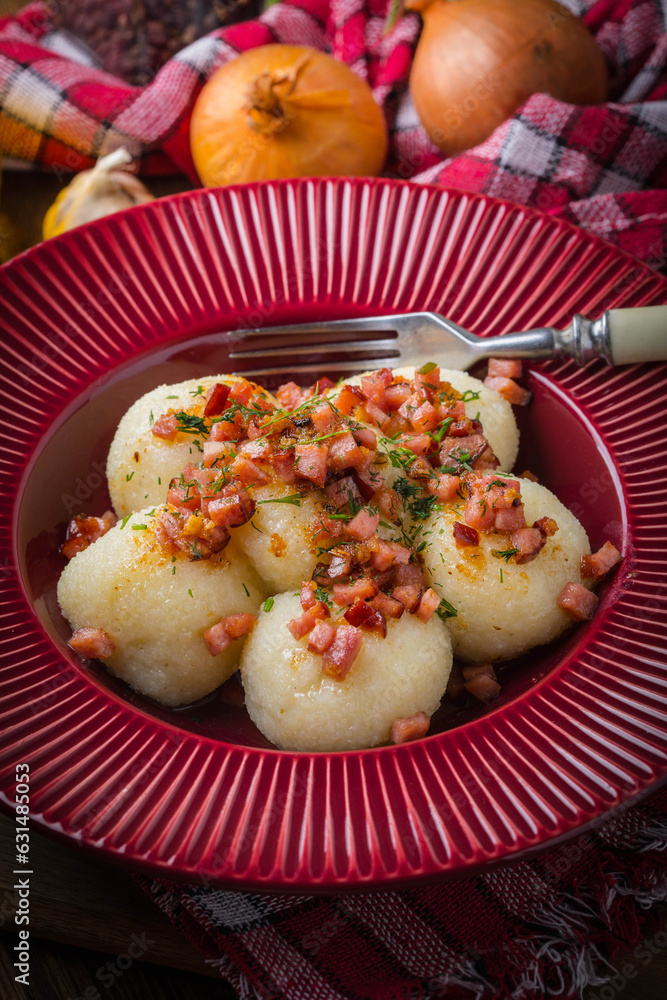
left=0, top=174, right=667, bottom=891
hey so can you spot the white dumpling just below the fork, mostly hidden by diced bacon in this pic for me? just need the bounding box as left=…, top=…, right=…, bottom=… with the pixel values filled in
left=329, top=365, right=519, bottom=472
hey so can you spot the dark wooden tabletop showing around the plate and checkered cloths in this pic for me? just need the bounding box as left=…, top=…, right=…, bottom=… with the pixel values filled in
left=0, top=0, right=667, bottom=1000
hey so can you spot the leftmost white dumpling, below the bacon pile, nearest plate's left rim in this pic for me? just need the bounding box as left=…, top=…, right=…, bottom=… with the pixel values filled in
left=58, top=510, right=264, bottom=707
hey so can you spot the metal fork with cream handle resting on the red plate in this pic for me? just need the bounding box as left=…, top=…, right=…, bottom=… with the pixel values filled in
left=229, top=305, right=667, bottom=375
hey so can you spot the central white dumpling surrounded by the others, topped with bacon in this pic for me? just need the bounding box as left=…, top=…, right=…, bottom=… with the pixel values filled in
left=233, top=483, right=324, bottom=593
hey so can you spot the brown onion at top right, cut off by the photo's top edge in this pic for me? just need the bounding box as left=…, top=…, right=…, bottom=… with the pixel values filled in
left=406, top=0, right=608, bottom=156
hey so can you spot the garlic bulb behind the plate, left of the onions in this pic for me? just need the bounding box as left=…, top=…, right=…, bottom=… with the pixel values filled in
left=42, top=148, right=154, bottom=240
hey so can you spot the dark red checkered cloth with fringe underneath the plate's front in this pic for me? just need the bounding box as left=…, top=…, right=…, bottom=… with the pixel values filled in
left=138, top=792, right=667, bottom=1000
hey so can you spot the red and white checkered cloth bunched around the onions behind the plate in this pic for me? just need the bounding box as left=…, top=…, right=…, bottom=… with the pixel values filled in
left=0, top=0, right=667, bottom=267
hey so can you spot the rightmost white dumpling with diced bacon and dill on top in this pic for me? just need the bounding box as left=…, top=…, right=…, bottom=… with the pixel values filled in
left=422, top=479, right=590, bottom=663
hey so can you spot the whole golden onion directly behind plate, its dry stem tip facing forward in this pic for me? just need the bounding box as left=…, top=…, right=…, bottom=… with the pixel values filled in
left=190, top=45, right=387, bottom=187
